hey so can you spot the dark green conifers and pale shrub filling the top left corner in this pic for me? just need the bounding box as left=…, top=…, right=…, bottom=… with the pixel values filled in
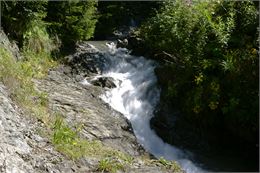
left=2, top=0, right=97, bottom=52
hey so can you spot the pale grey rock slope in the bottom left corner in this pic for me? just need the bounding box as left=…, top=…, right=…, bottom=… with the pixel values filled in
left=0, top=83, right=91, bottom=173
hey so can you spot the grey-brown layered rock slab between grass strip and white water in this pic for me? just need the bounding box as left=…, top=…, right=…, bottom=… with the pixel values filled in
left=35, top=66, right=141, bottom=155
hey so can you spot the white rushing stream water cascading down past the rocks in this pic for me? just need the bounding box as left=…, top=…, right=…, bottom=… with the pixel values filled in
left=85, top=43, right=202, bottom=173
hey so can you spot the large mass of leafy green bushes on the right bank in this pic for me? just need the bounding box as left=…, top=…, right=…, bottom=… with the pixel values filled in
left=140, top=0, right=259, bottom=141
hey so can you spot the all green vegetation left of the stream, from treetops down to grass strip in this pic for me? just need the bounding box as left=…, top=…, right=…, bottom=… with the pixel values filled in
left=0, top=1, right=132, bottom=170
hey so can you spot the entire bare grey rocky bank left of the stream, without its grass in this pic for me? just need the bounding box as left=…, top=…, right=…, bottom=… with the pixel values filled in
left=0, top=31, right=183, bottom=173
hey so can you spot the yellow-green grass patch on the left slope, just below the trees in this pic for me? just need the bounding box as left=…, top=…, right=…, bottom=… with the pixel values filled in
left=0, top=47, right=56, bottom=122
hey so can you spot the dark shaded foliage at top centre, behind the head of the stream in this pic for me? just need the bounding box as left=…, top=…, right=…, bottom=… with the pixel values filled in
left=95, top=1, right=160, bottom=39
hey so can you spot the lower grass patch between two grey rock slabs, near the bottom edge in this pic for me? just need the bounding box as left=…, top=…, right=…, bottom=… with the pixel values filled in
left=52, top=115, right=134, bottom=172
